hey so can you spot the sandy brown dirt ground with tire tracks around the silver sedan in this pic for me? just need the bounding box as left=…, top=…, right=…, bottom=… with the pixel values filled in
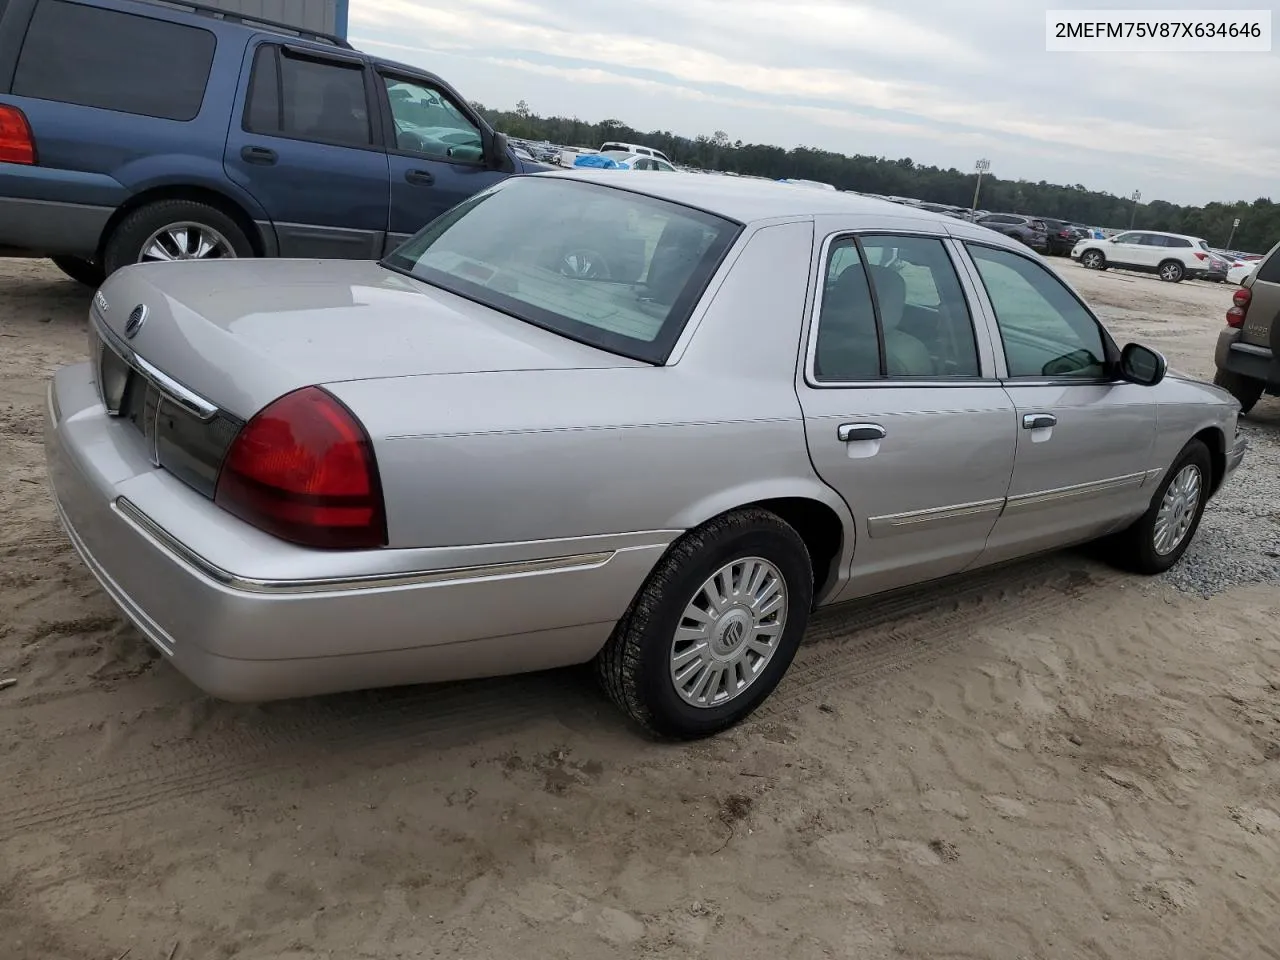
left=0, top=261, right=1280, bottom=960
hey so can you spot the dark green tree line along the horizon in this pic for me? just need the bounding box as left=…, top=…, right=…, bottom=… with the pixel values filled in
left=472, top=101, right=1280, bottom=253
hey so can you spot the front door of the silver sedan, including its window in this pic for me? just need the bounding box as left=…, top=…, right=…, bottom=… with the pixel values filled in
left=965, top=241, right=1158, bottom=562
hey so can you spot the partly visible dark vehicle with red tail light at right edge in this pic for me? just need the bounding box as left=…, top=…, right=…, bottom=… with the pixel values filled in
left=1213, top=243, right=1280, bottom=413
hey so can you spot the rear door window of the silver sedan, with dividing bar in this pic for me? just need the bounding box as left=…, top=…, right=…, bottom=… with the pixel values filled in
left=814, top=234, right=980, bottom=380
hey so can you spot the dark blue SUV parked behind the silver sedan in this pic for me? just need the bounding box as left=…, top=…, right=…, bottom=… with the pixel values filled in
left=0, top=0, right=548, bottom=284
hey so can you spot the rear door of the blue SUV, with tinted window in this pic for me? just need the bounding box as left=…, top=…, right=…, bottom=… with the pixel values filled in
left=223, top=42, right=388, bottom=260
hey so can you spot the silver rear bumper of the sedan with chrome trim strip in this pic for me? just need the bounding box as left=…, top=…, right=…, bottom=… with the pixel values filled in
left=45, top=364, right=669, bottom=700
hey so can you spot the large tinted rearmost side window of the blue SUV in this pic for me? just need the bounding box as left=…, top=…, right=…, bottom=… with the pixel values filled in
left=11, top=0, right=216, bottom=120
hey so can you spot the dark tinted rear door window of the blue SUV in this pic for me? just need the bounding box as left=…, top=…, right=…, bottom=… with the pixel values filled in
left=244, top=44, right=372, bottom=147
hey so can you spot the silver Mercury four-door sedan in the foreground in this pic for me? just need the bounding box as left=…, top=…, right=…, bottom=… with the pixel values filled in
left=46, top=172, right=1244, bottom=737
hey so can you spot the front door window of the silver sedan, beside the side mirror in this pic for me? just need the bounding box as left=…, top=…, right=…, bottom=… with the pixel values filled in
left=968, top=244, right=1107, bottom=380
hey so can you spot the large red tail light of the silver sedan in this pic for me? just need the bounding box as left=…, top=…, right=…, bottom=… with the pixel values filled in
left=214, top=387, right=387, bottom=549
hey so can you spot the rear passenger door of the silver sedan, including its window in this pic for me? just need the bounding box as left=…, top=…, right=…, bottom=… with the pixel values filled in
left=797, top=225, right=1016, bottom=599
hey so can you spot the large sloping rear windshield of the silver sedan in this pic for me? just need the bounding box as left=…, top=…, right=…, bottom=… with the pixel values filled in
left=383, top=177, right=741, bottom=364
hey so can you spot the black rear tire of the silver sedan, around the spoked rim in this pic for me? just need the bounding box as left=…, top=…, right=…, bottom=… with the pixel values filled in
left=595, top=508, right=813, bottom=740
